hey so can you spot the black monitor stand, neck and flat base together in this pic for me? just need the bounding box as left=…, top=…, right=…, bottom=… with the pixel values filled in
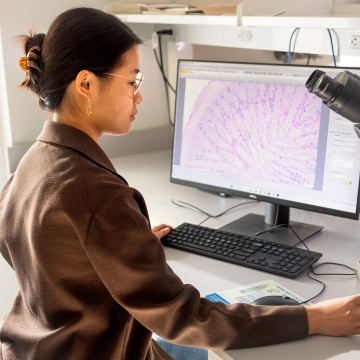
left=221, top=203, right=323, bottom=246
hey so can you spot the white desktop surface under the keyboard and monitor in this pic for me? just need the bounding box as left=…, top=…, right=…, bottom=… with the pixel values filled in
left=112, top=151, right=360, bottom=360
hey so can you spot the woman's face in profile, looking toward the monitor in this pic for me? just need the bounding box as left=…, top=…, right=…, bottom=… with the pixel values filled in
left=89, top=46, right=142, bottom=136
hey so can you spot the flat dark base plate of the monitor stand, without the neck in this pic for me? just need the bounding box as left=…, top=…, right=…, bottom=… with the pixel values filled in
left=220, top=213, right=323, bottom=246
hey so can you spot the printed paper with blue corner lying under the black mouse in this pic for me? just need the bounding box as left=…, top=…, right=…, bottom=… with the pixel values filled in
left=205, top=280, right=305, bottom=304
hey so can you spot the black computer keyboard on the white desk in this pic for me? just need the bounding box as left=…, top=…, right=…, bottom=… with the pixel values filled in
left=161, top=223, right=322, bottom=278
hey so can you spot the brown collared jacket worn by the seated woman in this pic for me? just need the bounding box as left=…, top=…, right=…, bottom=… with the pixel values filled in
left=0, top=121, right=308, bottom=360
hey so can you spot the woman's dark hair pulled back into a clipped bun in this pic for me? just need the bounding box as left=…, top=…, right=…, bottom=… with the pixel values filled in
left=21, top=7, right=142, bottom=111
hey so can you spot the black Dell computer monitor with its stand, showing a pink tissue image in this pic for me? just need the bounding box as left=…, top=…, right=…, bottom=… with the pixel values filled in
left=170, top=60, right=360, bottom=245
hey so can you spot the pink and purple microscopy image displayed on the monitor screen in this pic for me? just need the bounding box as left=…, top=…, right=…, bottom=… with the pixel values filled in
left=181, top=79, right=321, bottom=188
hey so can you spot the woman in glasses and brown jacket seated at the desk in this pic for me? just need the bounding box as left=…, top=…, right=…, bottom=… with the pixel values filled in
left=0, top=8, right=360, bottom=360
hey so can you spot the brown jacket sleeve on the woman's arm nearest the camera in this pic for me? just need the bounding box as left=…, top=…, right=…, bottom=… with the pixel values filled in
left=85, top=196, right=308, bottom=349
